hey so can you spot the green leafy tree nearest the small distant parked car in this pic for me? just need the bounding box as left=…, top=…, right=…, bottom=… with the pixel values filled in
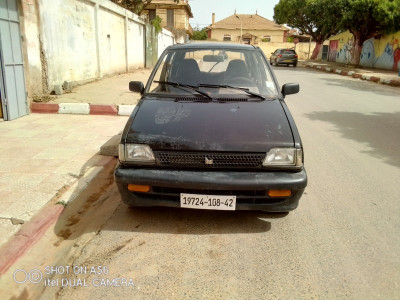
left=274, top=0, right=343, bottom=59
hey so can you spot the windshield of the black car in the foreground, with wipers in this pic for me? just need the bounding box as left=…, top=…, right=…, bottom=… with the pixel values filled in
left=146, top=48, right=278, bottom=99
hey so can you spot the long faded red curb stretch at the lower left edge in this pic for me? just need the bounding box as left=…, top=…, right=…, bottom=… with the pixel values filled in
left=0, top=205, right=64, bottom=276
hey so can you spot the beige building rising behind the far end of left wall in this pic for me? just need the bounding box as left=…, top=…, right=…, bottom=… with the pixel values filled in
left=142, top=0, right=193, bottom=43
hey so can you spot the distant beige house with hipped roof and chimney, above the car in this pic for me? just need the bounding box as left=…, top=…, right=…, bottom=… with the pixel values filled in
left=208, top=13, right=289, bottom=45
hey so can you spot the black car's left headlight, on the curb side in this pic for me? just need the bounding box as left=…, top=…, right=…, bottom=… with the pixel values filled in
left=118, top=144, right=155, bottom=163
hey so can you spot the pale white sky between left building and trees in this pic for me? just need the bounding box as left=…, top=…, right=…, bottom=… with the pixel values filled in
left=189, top=0, right=279, bottom=28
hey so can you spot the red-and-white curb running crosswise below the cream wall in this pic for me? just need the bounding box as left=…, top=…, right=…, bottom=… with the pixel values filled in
left=30, top=102, right=136, bottom=116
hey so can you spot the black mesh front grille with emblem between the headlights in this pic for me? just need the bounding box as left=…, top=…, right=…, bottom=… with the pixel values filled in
left=154, top=151, right=265, bottom=169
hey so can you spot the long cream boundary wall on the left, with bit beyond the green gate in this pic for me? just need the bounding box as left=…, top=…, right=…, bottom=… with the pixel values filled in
left=22, top=0, right=173, bottom=96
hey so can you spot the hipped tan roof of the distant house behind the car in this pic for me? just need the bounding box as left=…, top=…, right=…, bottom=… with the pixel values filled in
left=209, top=14, right=289, bottom=30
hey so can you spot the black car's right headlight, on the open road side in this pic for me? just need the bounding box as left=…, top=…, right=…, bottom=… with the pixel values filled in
left=263, top=148, right=303, bottom=167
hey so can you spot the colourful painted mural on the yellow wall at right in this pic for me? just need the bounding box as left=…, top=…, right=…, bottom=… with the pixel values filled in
left=331, top=32, right=400, bottom=71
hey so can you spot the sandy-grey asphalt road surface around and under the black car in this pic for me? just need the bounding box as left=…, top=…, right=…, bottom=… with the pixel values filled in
left=14, top=67, right=400, bottom=299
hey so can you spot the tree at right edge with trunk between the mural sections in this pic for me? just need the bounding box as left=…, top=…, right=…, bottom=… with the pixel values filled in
left=336, top=0, right=400, bottom=65
